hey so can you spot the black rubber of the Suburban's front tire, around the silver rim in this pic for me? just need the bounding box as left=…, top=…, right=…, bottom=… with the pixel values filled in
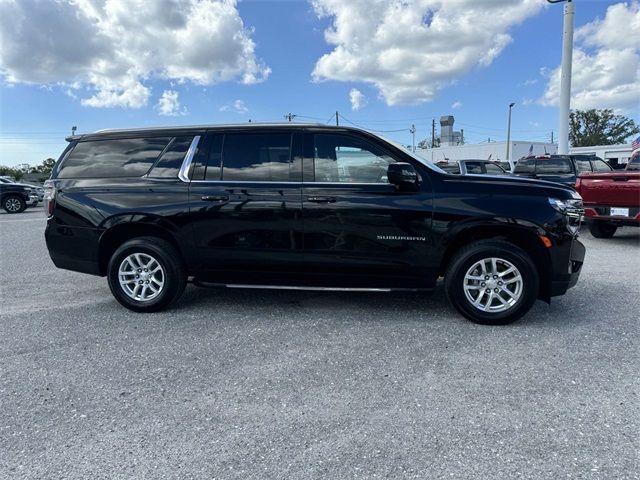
left=445, top=240, right=540, bottom=325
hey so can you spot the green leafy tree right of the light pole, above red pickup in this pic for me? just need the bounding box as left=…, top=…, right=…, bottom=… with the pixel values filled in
left=569, top=108, right=640, bottom=147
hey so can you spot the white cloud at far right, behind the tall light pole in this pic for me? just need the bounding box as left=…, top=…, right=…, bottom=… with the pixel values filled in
left=540, top=1, right=640, bottom=112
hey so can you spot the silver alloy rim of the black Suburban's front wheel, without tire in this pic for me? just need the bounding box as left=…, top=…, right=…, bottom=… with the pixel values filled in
left=464, top=257, right=524, bottom=313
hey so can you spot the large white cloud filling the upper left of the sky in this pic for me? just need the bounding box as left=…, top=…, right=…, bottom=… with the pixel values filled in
left=0, top=0, right=271, bottom=108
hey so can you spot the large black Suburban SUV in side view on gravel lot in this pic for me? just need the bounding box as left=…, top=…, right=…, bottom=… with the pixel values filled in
left=45, top=124, right=585, bottom=324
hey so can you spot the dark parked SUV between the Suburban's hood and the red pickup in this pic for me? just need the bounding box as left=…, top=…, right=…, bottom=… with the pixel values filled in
left=513, top=155, right=613, bottom=186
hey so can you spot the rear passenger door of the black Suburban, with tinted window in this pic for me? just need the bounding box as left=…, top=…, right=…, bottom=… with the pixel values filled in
left=189, top=128, right=302, bottom=284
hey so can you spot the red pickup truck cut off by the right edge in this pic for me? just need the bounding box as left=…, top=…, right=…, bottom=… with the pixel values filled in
left=576, top=155, right=640, bottom=238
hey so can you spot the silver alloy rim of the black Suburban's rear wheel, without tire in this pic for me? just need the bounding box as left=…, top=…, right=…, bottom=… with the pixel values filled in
left=118, top=253, right=165, bottom=302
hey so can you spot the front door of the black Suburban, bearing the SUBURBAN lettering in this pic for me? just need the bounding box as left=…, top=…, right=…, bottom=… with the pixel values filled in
left=302, top=131, right=433, bottom=288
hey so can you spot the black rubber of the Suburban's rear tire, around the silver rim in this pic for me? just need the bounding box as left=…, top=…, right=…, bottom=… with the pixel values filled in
left=107, top=237, right=187, bottom=312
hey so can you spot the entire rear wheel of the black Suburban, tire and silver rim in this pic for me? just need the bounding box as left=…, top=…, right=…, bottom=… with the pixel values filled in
left=107, top=237, right=187, bottom=312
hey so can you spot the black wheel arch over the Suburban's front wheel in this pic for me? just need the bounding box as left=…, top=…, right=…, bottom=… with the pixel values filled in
left=438, top=223, right=552, bottom=302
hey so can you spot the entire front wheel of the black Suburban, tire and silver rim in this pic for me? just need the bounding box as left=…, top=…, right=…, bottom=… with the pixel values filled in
left=445, top=240, right=540, bottom=325
